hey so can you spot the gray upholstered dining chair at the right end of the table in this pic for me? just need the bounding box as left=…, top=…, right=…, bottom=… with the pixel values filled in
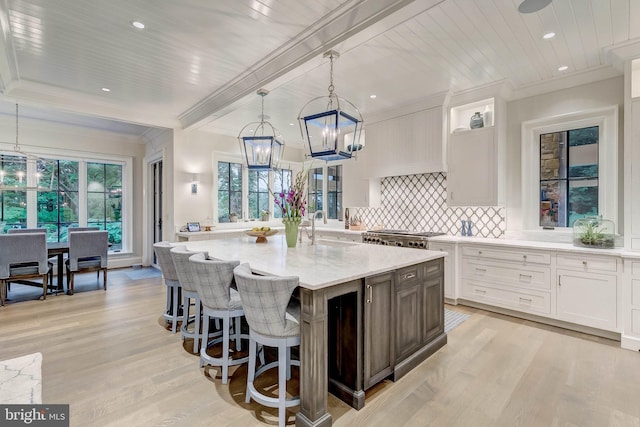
left=65, top=231, right=109, bottom=295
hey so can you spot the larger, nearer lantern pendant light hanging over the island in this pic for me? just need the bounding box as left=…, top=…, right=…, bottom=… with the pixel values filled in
left=298, top=50, right=364, bottom=161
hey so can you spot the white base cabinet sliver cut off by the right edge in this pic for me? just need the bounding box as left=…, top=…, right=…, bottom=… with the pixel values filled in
left=621, top=260, right=640, bottom=351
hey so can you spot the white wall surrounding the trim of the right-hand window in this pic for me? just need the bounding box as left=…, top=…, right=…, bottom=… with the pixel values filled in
left=506, top=76, right=624, bottom=233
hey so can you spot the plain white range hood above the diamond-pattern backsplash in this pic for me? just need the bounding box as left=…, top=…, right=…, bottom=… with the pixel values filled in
left=364, top=106, right=445, bottom=180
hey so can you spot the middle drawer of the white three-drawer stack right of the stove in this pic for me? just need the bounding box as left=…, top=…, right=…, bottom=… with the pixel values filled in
left=462, top=258, right=551, bottom=290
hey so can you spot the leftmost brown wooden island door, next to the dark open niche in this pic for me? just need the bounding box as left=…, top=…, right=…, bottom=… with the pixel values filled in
left=363, top=273, right=395, bottom=390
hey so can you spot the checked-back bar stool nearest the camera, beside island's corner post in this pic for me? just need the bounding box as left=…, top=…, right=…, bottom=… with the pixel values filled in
left=233, top=263, right=300, bottom=427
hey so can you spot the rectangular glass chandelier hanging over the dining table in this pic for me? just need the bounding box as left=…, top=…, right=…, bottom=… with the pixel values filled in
left=0, top=104, right=55, bottom=191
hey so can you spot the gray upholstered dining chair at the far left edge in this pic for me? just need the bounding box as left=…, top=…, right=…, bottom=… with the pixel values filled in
left=0, top=233, right=50, bottom=305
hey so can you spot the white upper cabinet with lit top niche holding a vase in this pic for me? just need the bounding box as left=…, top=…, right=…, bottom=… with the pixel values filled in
left=447, top=98, right=506, bottom=206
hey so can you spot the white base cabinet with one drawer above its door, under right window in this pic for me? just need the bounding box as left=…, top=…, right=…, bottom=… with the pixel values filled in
left=556, top=254, right=619, bottom=332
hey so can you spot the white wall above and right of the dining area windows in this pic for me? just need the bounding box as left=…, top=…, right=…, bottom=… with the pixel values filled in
left=0, top=116, right=145, bottom=267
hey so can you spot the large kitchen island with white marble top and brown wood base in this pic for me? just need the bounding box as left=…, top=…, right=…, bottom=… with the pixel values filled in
left=184, top=235, right=446, bottom=426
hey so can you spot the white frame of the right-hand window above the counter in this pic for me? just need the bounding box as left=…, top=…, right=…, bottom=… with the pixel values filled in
left=521, top=105, right=621, bottom=233
